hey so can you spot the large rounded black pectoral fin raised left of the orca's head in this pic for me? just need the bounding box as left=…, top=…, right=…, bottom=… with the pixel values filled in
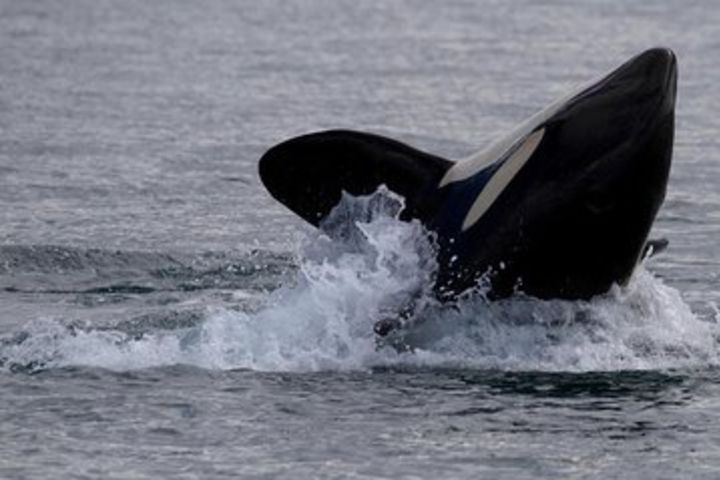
left=259, top=130, right=452, bottom=226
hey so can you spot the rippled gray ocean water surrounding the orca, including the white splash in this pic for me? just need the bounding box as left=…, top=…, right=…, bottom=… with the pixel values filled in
left=0, top=0, right=720, bottom=479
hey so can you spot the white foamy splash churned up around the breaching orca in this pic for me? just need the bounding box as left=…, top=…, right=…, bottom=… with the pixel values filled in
left=0, top=190, right=720, bottom=371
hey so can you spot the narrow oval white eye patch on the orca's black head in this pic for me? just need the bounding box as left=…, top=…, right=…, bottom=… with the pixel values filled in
left=462, top=128, right=545, bottom=231
